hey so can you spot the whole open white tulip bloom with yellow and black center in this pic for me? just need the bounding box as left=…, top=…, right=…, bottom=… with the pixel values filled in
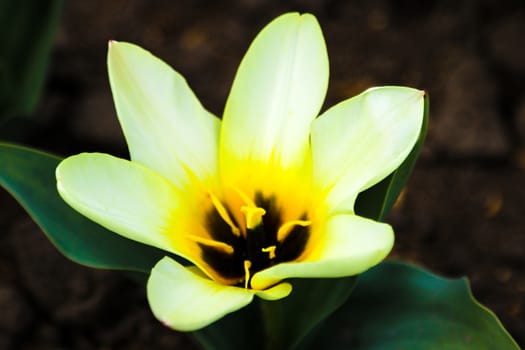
left=57, top=13, right=424, bottom=330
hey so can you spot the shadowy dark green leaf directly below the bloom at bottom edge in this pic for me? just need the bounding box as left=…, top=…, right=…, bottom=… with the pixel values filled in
left=192, top=277, right=356, bottom=350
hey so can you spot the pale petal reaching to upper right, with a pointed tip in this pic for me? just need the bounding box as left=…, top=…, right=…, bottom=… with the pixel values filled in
left=312, top=87, right=424, bottom=213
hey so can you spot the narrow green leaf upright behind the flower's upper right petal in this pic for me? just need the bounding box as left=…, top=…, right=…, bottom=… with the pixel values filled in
left=355, top=93, right=429, bottom=220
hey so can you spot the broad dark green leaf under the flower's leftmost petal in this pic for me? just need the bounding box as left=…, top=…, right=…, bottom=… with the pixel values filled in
left=0, top=143, right=167, bottom=273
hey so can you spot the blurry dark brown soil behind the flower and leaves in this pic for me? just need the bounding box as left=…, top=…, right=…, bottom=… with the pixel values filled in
left=0, top=0, right=525, bottom=349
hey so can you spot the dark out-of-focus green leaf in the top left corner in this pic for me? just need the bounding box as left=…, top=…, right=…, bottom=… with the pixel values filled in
left=0, top=0, right=63, bottom=118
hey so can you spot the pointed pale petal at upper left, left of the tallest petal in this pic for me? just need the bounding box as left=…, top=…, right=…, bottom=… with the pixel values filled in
left=108, top=41, right=220, bottom=193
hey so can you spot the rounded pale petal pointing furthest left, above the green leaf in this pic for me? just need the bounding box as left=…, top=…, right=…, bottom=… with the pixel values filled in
left=56, top=153, right=187, bottom=255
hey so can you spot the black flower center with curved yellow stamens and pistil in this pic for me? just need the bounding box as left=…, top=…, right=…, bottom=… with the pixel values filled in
left=188, top=190, right=311, bottom=288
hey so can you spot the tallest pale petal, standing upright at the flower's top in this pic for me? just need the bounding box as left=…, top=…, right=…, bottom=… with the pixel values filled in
left=220, top=13, right=328, bottom=195
